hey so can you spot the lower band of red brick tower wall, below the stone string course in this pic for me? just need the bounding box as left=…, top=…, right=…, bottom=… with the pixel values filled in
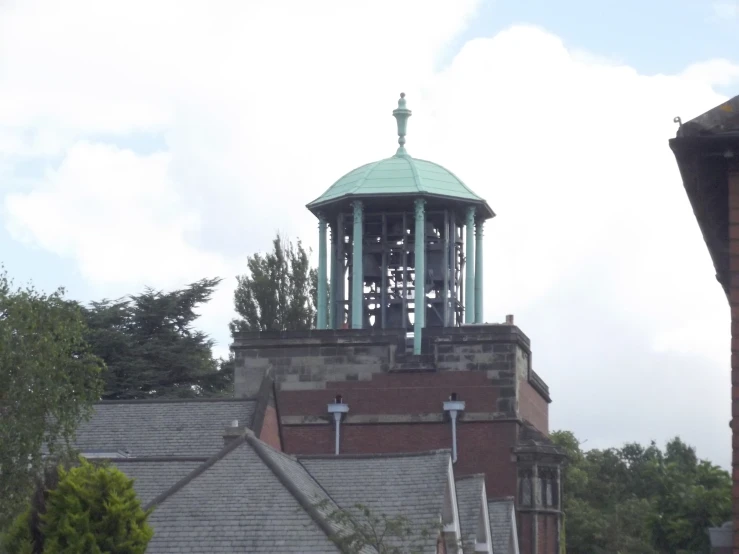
left=282, top=421, right=518, bottom=498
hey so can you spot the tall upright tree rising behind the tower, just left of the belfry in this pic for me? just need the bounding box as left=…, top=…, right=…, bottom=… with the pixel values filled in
left=230, top=234, right=318, bottom=334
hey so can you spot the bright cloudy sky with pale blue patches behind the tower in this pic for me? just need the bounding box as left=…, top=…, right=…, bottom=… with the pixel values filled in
left=0, top=0, right=739, bottom=467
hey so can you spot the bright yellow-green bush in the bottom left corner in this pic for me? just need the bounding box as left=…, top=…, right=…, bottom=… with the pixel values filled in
left=2, top=459, right=154, bottom=554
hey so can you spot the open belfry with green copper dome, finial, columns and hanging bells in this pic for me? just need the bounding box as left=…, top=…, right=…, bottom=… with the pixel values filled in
left=307, top=93, right=495, bottom=354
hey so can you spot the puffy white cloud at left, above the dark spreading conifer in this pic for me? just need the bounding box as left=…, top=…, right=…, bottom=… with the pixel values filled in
left=5, top=142, right=224, bottom=286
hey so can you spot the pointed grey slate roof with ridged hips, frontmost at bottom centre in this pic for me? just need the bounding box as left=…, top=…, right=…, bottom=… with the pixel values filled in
left=147, top=434, right=338, bottom=554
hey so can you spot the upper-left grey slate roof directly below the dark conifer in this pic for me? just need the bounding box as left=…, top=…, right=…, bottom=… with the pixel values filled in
left=74, top=399, right=256, bottom=457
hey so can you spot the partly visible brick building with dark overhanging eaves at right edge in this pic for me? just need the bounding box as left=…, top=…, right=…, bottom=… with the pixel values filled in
left=670, top=96, right=739, bottom=553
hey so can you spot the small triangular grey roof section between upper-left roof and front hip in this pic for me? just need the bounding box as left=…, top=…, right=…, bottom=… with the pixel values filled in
left=111, top=458, right=205, bottom=505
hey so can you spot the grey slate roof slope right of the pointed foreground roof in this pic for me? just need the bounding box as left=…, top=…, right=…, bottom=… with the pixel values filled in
left=298, top=450, right=450, bottom=552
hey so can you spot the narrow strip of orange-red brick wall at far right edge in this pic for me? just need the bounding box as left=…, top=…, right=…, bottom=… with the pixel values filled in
left=729, top=158, right=739, bottom=554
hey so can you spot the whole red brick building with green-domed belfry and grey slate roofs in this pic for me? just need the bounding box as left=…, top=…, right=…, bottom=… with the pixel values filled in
left=75, top=95, right=563, bottom=554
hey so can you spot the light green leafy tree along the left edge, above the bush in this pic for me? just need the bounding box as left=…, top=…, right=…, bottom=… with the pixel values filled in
left=0, top=271, right=103, bottom=529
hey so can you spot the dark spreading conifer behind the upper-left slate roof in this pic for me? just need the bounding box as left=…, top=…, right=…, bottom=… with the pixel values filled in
left=84, top=279, right=233, bottom=399
